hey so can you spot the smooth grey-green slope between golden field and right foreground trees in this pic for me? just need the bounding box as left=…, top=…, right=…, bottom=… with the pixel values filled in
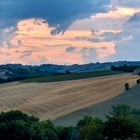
left=54, top=82, right=140, bottom=126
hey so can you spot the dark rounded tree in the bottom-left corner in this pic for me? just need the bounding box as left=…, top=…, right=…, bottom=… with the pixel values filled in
left=0, top=111, right=39, bottom=140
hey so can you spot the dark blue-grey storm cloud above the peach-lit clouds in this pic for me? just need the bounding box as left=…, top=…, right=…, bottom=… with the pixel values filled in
left=0, top=0, right=110, bottom=34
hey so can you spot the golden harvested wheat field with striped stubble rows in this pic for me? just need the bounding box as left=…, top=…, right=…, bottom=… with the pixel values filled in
left=0, top=74, right=139, bottom=120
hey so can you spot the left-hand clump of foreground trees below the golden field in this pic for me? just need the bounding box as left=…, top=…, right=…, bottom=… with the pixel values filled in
left=0, top=111, right=74, bottom=140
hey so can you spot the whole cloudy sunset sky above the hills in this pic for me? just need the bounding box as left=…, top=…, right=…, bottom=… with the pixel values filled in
left=0, top=0, right=140, bottom=65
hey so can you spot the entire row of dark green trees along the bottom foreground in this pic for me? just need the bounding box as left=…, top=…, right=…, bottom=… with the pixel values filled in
left=0, top=105, right=140, bottom=140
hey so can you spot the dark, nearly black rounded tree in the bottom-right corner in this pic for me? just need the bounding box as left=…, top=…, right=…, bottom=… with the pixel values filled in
left=103, top=116, right=140, bottom=140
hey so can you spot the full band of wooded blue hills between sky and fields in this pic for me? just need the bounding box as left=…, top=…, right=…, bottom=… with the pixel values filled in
left=0, top=61, right=140, bottom=81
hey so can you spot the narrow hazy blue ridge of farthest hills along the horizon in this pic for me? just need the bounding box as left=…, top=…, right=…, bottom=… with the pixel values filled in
left=0, top=61, right=140, bottom=74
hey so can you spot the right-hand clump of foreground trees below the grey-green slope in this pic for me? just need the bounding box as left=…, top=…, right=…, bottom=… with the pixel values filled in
left=77, top=105, right=140, bottom=140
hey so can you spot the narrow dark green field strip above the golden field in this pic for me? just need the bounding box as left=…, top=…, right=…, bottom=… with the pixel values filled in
left=22, top=70, right=123, bottom=83
